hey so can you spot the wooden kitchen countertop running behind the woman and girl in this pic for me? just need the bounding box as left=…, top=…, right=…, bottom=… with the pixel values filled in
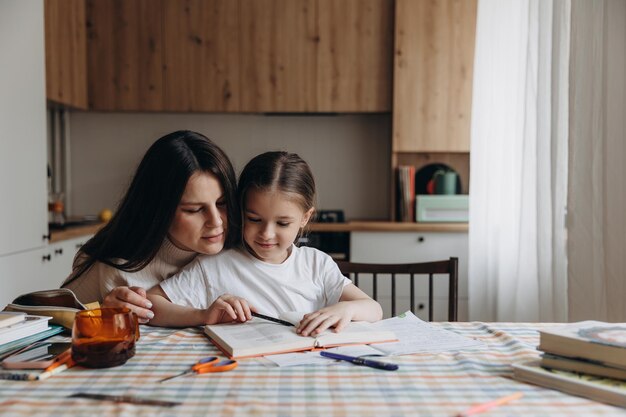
left=50, top=220, right=468, bottom=243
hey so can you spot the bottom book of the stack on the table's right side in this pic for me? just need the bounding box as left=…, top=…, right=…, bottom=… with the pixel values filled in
left=513, top=361, right=626, bottom=408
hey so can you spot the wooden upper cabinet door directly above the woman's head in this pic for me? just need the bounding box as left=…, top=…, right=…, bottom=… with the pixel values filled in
left=162, top=0, right=239, bottom=112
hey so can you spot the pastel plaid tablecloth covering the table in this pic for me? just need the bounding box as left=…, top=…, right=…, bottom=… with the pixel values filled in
left=0, top=323, right=626, bottom=417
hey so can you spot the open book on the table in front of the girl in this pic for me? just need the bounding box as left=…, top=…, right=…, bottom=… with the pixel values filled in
left=204, top=312, right=396, bottom=358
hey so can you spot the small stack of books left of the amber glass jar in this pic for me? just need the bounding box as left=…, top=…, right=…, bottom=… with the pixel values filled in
left=0, top=311, right=63, bottom=359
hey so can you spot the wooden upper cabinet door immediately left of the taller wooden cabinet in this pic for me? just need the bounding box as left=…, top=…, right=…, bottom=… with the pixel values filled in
left=317, top=0, right=394, bottom=112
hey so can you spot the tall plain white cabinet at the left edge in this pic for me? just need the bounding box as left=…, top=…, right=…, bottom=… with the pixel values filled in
left=0, top=1, right=48, bottom=256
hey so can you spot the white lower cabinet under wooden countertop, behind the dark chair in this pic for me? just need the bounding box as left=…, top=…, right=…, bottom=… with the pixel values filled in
left=350, top=232, right=469, bottom=321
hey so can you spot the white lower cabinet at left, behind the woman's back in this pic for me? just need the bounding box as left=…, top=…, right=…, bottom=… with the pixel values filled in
left=0, top=236, right=90, bottom=310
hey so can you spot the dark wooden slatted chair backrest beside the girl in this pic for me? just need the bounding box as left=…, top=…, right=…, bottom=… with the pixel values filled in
left=336, top=258, right=459, bottom=321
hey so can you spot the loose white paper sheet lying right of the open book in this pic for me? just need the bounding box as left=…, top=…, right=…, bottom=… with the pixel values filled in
left=375, top=311, right=485, bottom=355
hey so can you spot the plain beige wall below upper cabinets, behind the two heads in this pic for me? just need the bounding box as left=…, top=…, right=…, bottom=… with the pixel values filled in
left=68, top=112, right=391, bottom=219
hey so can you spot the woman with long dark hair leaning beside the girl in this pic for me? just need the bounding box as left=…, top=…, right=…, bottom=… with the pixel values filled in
left=62, top=131, right=240, bottom=322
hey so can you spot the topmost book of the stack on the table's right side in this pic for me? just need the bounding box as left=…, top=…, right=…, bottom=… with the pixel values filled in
left=539, top=321, right=626, bottom=368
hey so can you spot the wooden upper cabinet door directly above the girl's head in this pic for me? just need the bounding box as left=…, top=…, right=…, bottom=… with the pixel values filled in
left=240, top=0, right=319, bottom=112
